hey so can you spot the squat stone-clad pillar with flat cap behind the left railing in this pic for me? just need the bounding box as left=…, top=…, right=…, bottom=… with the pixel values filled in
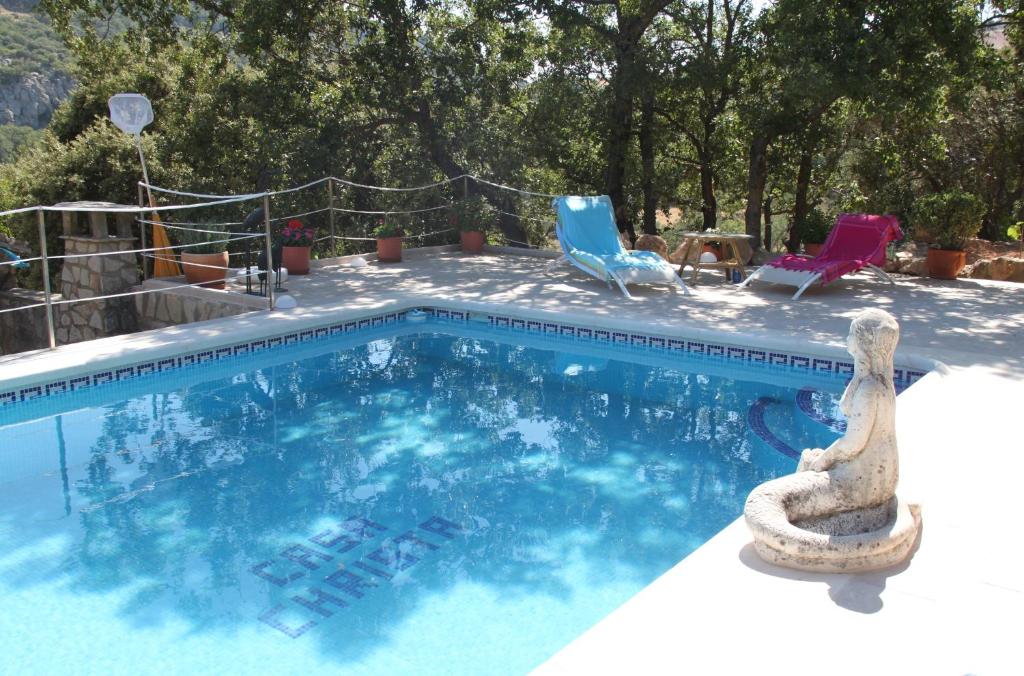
left=55, top=236, right=139, bottom=344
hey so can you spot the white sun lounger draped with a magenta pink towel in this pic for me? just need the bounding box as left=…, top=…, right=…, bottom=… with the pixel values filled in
left=739, top=214, right=903, bottom=300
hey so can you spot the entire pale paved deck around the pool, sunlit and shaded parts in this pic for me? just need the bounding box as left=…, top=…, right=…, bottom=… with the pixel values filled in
left=0, top=246, right=1024, bottom=674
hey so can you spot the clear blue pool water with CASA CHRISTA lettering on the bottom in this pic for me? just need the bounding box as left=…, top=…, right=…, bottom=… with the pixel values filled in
left=0, top=326, right=842, bottom=675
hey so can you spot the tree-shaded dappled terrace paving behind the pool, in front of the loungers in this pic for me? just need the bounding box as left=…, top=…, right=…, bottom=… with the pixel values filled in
left=285, top=252, right=1024, bottom=375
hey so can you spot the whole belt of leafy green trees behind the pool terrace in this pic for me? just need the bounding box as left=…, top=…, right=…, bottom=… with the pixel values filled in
left=0, top=0, right=1024, bottom=284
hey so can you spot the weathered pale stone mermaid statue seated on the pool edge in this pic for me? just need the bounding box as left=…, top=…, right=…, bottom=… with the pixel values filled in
left=743, top=309, right=921, bottom=573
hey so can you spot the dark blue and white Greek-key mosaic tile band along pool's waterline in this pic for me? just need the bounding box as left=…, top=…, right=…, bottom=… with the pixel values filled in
left=0, top=307, right=926, bottom=407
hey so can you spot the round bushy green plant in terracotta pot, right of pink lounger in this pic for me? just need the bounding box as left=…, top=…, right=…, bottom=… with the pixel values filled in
left=912, top=188, right=985, bottom=280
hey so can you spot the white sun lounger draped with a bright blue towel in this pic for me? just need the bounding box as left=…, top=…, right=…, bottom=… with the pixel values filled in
left=548, top=195, right=689, bottom=298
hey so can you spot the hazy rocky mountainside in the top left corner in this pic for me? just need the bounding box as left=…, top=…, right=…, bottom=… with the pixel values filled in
left=0, top=0, right=75, bottom=162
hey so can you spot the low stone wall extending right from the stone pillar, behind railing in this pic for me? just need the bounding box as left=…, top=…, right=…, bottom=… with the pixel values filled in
left=134, top=278, right=266, bottom=330
